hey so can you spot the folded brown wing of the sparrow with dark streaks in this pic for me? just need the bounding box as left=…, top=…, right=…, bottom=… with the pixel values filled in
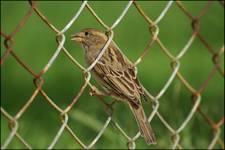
left=93, top=47, right=144, bottom=106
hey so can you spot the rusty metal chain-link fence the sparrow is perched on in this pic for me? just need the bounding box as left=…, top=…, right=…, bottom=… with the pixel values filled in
left=1, top=1, right=224, bottom=149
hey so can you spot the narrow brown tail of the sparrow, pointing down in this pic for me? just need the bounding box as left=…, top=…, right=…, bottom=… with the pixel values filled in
left=129, top=104, right=156, bottom=145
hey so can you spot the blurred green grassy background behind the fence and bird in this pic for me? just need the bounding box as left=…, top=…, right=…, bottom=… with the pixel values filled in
left=1, top=1, right=224, bottom=148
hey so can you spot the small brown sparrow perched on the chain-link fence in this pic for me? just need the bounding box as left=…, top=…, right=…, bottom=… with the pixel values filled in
left=71, top=28, right=156, bottom=144
